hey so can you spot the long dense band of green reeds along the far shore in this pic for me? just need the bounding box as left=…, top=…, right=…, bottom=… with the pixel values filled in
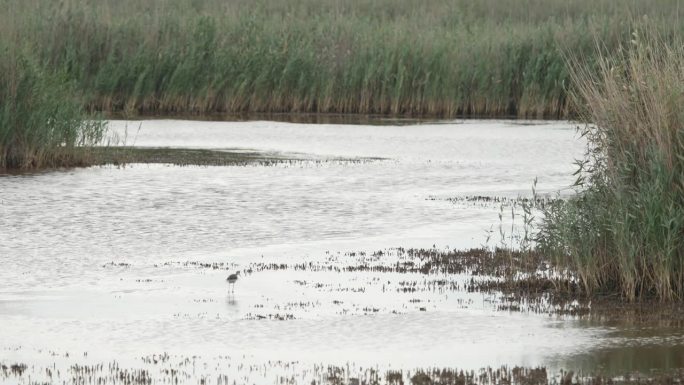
left=5, top=0, right=684, bottom=117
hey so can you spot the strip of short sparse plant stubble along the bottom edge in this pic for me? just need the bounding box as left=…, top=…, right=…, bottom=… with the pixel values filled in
left=5, top=358, right=684, bottom=385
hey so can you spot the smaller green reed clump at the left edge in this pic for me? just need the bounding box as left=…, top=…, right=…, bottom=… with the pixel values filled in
left=0, top=48, right=105, bottom=169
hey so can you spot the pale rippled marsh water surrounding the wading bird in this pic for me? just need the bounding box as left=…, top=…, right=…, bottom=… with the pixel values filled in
left=0, top=120, right=684, bottom=383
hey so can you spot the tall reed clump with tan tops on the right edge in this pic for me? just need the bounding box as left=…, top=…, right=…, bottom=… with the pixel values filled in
left=539, top=30, right=684, bottom=300
